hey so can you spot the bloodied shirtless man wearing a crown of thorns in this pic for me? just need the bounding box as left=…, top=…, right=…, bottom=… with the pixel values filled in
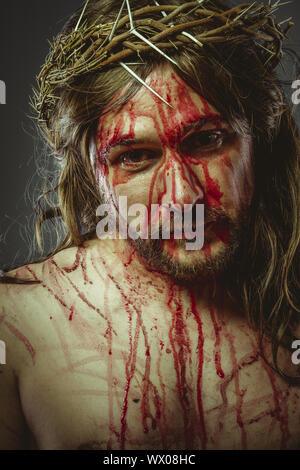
left=0, top=1, right=300, bottom=450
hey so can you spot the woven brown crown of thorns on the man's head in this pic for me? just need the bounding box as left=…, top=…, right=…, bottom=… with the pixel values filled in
left=32, top=0, right=293, bottom=123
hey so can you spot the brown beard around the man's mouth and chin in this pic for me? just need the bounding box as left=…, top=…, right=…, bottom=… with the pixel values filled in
left=128, top=207, right=248, bottom=283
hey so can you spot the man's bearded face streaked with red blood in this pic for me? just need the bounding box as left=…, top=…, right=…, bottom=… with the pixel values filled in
left=95, top=67, right=253, bottom=280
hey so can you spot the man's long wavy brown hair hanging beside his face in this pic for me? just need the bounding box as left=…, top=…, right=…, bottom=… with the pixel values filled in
left=2, top=0, right=300, bottom=382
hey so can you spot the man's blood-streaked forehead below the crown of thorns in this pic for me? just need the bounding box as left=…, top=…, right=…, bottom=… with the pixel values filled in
left=99, top=67, right=221, bottom=144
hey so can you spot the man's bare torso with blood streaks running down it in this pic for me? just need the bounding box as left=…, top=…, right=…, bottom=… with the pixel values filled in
left=0, top=241, right=300, bottom=450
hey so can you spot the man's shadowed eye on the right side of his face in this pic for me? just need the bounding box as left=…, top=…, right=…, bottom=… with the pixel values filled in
left=182, top=129, right=234, bottom=154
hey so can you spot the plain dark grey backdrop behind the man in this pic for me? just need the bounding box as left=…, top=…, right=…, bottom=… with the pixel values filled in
left=0, top=0, right=300, bottom=268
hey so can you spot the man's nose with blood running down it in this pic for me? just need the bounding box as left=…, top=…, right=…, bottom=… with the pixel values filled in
left=159, top=152, right=204, bottom=209
